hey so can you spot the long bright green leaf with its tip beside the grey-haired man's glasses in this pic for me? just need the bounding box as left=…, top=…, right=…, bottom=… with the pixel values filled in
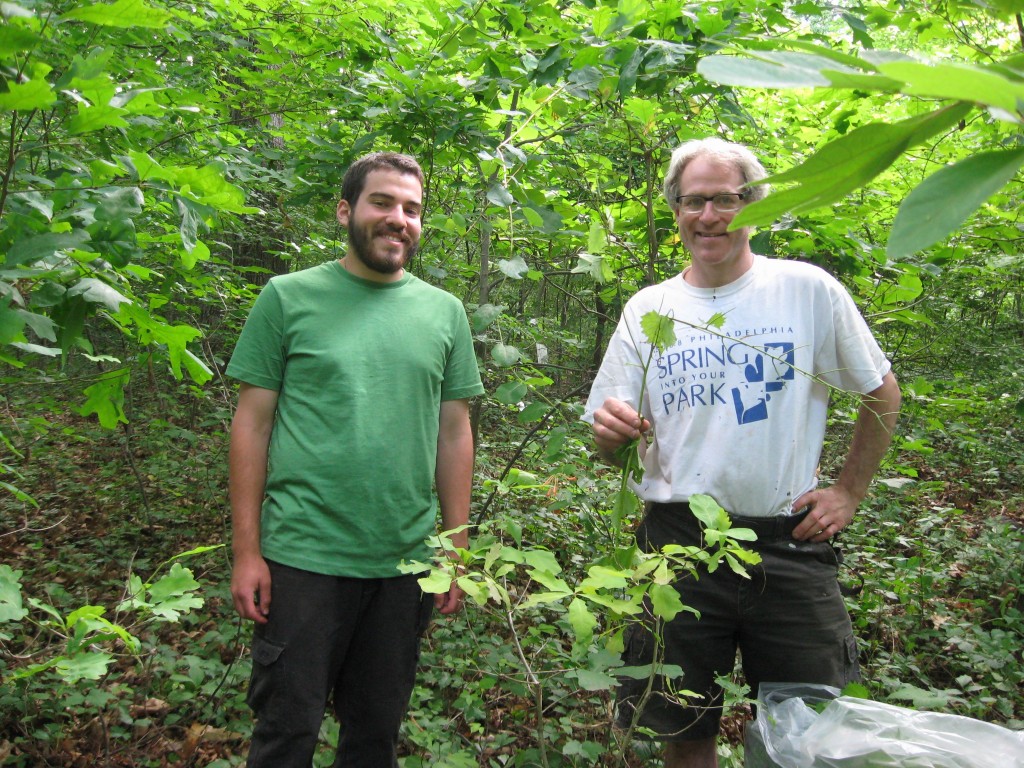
left=730, top=103, right=972, bottom=229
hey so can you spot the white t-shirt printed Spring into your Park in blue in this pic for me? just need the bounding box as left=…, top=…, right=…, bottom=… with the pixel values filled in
left=583, top=256, right=890, bottom=517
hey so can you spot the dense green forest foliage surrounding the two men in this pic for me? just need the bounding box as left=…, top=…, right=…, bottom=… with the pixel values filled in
left=0, top=0, right=1024, bottom=768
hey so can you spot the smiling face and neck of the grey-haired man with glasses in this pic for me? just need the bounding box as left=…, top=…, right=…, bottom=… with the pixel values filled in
left=675, top=156, right=754, bottom=288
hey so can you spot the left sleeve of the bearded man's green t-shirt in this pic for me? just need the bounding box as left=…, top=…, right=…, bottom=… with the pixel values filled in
left=227, top=281, right=285, bottom=391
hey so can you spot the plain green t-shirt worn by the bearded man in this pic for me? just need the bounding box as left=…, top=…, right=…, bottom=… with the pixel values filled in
left=227, top=261, right=483, bottom=579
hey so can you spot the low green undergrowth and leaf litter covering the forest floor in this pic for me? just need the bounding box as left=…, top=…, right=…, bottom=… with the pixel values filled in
left=0, top=364, right=1024, bottom=768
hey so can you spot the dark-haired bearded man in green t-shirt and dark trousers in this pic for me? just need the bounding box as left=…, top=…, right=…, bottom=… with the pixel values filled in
left=227, top=153, right=483, bottom=768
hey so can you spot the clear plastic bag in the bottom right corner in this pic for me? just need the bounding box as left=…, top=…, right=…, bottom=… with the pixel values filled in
left=744, top=683, right=1024, bottom=768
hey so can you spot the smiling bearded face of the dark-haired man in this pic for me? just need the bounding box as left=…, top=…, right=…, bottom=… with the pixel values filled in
left=338, top=169, right=423, bottom=283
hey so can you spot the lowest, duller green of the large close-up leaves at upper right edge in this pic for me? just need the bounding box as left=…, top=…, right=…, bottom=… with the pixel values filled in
left=886, top=147, right=1024, bottom=259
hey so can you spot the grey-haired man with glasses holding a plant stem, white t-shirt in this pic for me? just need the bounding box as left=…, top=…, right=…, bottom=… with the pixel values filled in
left=584, top=138, right=900, bottom=768
